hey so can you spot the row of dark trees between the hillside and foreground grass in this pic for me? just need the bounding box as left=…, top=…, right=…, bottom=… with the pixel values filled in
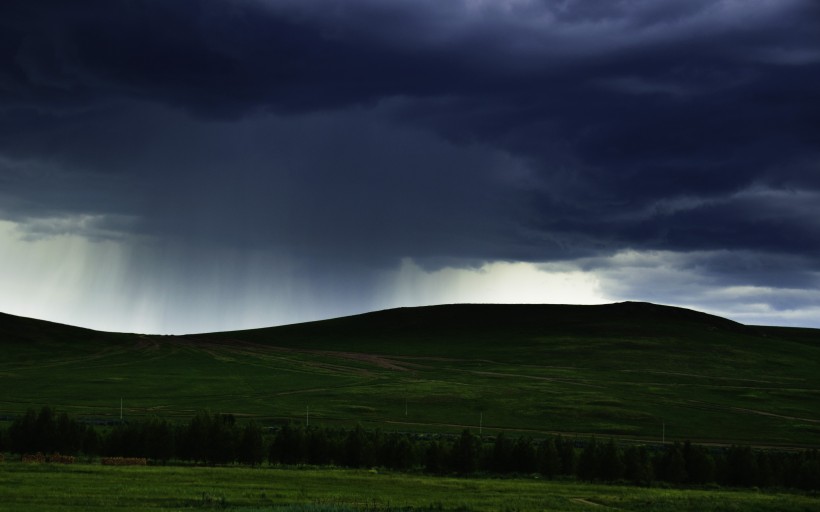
left=0, top=407, right=820, bottom=490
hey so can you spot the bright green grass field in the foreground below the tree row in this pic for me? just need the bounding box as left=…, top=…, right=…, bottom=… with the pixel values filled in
left=0, top=461, right=820, bottom=512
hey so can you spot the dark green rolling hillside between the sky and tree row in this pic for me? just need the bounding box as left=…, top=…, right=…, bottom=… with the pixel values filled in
left=0, top=303, right=820, bottom=446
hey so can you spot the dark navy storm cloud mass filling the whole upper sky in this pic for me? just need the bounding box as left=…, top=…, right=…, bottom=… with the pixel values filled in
left=0, top=0, right=820, bottom=278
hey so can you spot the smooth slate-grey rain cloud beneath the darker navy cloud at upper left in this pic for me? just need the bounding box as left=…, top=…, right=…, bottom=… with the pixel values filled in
left=0, top=98, right=519, bottom=267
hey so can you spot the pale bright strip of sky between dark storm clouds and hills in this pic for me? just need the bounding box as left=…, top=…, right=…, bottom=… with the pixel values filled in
left=0, top=222, right=820, bottom=334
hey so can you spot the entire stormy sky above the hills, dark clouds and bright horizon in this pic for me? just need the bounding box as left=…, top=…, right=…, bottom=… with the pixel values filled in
left=0, top=0, right=820, bottom=333
